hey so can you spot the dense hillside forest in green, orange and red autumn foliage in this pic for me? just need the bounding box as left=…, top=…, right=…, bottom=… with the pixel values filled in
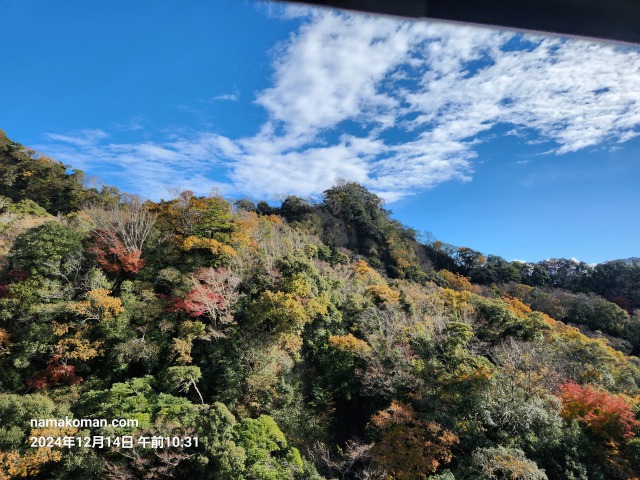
left=0, top=131, right=640, bottom=480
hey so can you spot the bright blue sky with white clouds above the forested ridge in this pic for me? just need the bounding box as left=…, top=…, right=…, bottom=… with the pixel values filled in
left=0, top=0, right=640, bottom=262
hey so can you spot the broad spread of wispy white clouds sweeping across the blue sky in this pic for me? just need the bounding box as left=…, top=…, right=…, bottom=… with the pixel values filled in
left=37, top=8, right=640, bottom=201
